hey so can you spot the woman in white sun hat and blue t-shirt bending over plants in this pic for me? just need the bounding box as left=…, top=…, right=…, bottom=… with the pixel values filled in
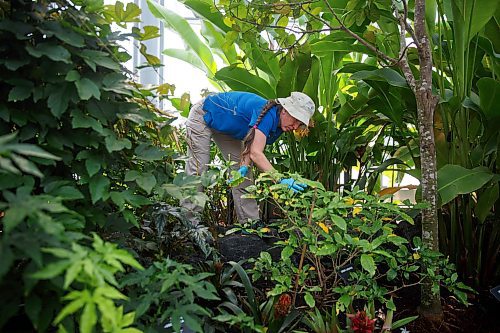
left=183, top=91, right=315, bottom=223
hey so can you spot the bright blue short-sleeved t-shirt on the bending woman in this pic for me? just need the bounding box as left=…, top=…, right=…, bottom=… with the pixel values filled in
left=203, top=91, right=283, bottom=144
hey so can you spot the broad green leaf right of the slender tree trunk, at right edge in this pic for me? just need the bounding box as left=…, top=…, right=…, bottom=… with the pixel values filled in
left=437, top=164, right=493, bottom=205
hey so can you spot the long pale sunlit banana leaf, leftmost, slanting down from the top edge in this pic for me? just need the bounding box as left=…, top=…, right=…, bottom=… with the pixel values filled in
left=147, top=0, right=217, bottom=78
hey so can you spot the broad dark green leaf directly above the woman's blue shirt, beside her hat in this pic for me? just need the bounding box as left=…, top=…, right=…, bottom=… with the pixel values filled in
left=215, top=67, right=276, bottom=99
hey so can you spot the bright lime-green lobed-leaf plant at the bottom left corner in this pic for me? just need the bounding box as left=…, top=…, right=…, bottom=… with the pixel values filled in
left=31, top=234, right=143, bottom=333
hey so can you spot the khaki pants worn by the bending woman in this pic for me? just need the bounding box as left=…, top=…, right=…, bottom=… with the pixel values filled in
left=181, top=100, right=259, bottom=223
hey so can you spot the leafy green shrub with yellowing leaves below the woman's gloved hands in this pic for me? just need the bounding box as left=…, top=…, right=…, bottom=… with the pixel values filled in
left=248, top=174, right=471, bottom=321
